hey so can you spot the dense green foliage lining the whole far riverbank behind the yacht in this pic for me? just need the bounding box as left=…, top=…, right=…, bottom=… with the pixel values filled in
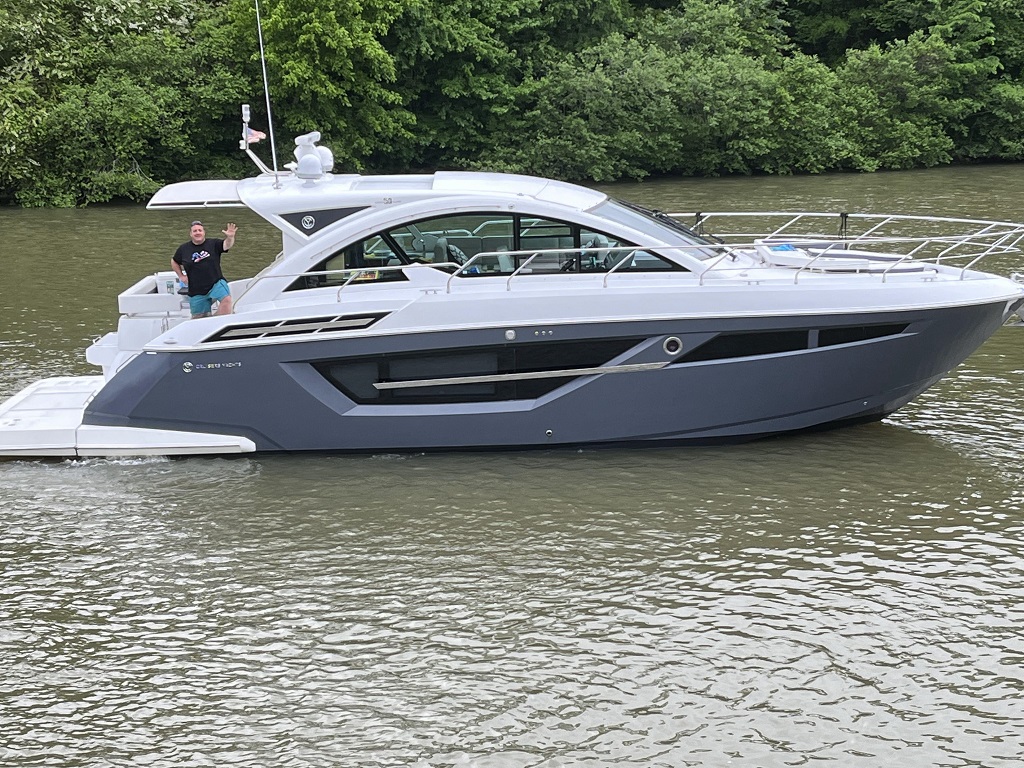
left=0, top=0, right=1024, bottom=206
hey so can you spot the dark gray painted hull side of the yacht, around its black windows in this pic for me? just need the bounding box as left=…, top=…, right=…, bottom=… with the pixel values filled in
left=84, top=302, right=1005, bottom=452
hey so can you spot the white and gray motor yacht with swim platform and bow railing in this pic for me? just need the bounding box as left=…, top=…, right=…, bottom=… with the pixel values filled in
left=0, top=126, right=1024, bottom=457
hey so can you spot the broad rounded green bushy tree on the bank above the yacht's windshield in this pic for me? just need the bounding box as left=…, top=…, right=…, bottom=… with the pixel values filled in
left=475, top=0, right=848, bottom=181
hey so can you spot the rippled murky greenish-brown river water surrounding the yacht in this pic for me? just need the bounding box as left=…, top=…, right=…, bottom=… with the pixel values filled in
left=0, top=166, right=1024, bottom=768
